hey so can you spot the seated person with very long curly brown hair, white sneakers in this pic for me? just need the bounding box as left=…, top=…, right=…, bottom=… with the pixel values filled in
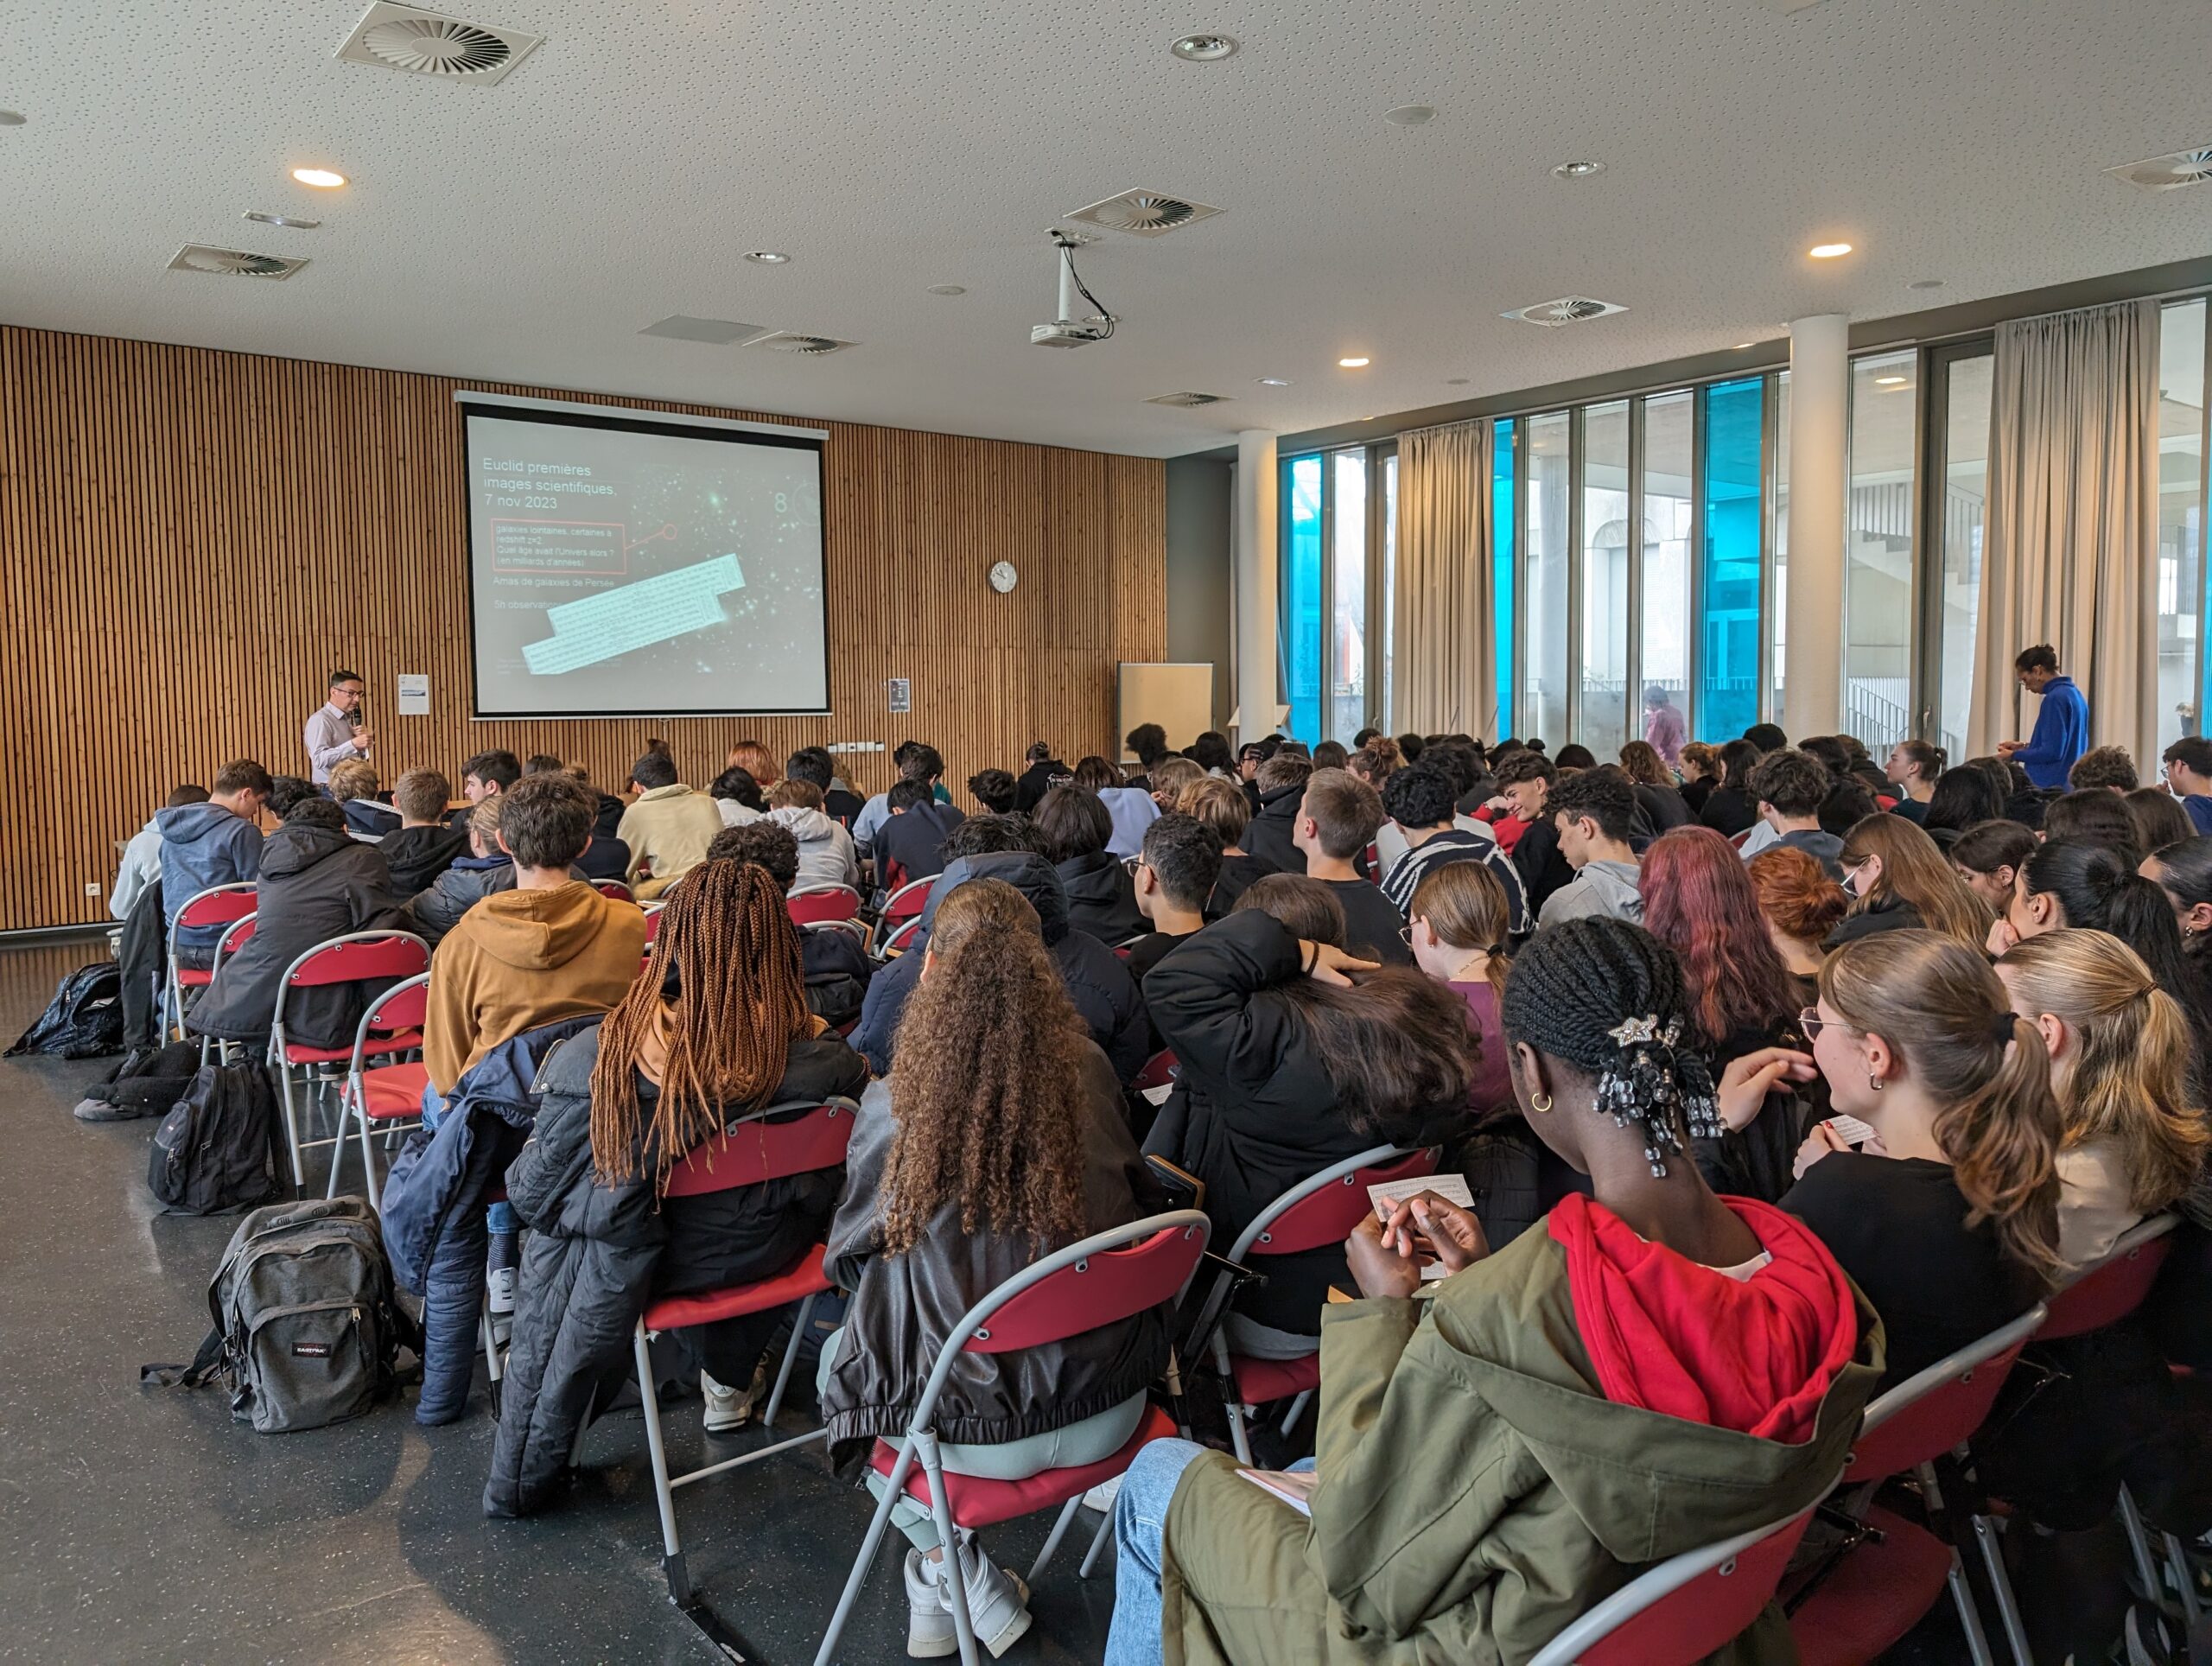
left=818, top=878, right=1168, bottom=1657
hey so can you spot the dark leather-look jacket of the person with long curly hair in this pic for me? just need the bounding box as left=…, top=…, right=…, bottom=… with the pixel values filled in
left=823, top=1046, right=1168, bottom=1460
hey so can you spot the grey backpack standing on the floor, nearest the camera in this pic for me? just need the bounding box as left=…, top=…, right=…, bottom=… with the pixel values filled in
left=139, top=1197, right=411, bottom=1434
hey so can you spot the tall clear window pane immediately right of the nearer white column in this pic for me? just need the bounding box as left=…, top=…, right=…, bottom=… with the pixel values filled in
left=1842, top=352, right=1920, bottom=757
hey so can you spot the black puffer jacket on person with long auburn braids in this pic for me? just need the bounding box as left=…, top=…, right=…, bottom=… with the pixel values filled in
left=485, top=1029, right=868, bottom=1516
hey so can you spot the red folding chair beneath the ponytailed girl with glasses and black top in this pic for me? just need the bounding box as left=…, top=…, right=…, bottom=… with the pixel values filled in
left=1789, top=1306, right=2044, bottom=1666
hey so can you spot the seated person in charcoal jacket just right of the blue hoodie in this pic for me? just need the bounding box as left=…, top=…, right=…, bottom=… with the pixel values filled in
left=186, top=797, right=407, bottom=1046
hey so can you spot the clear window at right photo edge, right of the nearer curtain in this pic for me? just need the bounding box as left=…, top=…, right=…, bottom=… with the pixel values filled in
left=2157, top=299, right=2205, bottom=753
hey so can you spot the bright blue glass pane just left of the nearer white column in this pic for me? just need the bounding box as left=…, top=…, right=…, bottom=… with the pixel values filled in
left=1694, top=376, right=1765, bottom=741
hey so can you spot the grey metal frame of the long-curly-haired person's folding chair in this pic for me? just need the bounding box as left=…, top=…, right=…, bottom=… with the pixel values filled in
left=814, top=1208, right=1212, bottom=1666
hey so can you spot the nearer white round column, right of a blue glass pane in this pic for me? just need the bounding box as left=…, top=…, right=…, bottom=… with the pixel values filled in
left=1781, top=312, right=1852, bottom=741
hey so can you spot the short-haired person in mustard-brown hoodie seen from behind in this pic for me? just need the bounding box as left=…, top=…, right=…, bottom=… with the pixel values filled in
left=423, top=774, right=646, bottom=1100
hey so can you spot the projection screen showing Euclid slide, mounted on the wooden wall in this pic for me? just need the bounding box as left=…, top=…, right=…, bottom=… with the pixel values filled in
left=462, top=396, right=830, bottom=717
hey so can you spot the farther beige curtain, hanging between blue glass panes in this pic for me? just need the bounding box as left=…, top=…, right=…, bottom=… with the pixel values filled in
left=1389, top=423, right=1500, bottom=741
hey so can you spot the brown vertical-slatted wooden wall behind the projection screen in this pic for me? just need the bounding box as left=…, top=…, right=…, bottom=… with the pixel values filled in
left=0, top=327, right=1166, bottom=929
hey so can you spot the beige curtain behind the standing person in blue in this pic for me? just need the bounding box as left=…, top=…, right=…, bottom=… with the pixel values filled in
left=1967, top=301, right=2159, bottom=761
